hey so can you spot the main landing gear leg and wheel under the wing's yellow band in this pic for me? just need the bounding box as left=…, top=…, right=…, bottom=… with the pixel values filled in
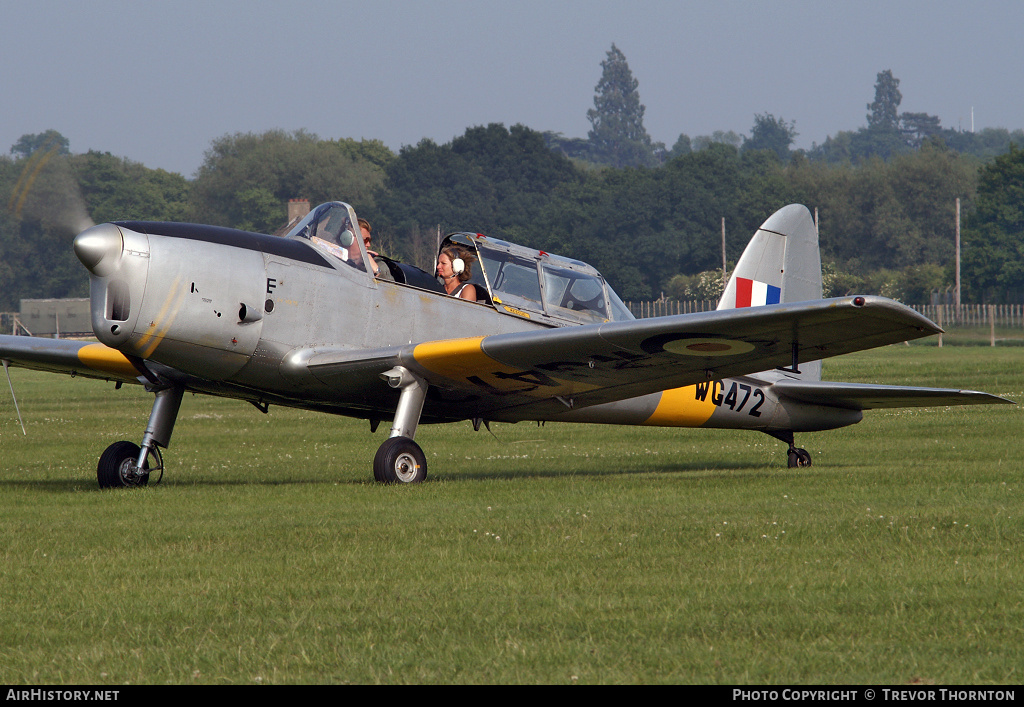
left=374, top=366, right=427, bottom=484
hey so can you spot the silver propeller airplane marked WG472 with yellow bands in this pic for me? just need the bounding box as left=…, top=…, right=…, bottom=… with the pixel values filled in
left=0, top=202, right=1011, bottom=488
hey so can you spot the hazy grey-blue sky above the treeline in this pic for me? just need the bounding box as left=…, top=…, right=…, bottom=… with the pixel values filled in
left=0, top=0, right=1024, bottom=176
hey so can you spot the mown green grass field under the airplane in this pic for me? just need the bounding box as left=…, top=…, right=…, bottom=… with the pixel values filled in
left=0, top=346, right=1024, bottom=684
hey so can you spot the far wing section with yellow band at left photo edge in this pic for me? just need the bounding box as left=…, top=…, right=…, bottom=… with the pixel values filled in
left=0, top=335, right=146, bottom=383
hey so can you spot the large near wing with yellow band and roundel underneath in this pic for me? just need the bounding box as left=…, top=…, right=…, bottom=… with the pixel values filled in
left=295, top=297, right=941, bottom=420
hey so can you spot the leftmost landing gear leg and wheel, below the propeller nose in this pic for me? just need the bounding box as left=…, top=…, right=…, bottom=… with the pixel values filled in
left=96, top=385, right=184, bottom=489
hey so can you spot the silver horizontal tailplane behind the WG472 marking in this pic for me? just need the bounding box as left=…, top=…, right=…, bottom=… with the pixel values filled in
left=772, top=380, right=1016, bottom=410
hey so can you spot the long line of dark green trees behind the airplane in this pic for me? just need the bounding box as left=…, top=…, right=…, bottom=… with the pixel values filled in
left=6, top=46, right=1024, bottom=309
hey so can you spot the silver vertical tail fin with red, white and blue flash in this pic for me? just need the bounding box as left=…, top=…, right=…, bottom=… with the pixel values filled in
left=718, top=204, right=821, bottom=380
